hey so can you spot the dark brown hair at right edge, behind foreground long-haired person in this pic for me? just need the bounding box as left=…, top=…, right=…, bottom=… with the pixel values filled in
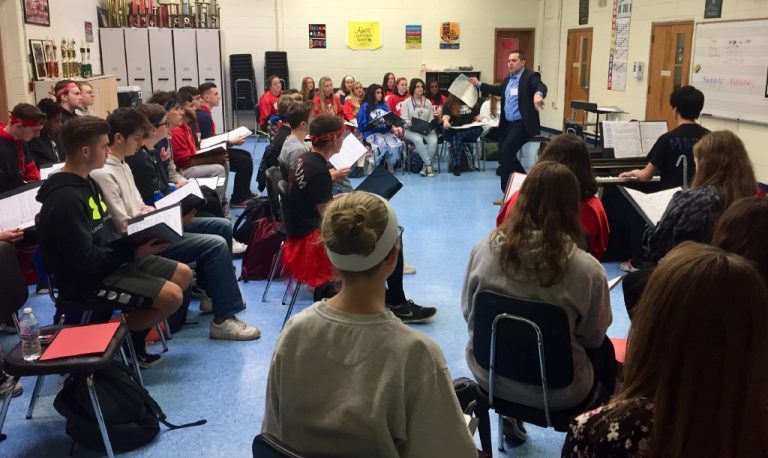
left=712, top=197, right=768, bottom=285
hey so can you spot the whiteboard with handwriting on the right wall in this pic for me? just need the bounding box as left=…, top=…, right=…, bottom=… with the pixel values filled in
left=691, top=19, right=768, bottom=124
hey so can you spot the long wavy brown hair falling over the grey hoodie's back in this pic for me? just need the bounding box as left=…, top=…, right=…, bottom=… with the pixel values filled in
left=491, top=161, right=586, bottom=287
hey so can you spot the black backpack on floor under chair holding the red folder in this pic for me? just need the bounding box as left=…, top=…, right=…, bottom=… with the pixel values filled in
left=53, top=361, right=206, bottom=452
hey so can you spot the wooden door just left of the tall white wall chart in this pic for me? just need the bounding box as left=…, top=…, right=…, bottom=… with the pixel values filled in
left=563, top=28, right=592, bottom=124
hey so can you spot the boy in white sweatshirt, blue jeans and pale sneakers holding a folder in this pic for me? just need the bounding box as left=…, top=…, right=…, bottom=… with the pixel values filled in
left=93, top=108, right=261, bottom=340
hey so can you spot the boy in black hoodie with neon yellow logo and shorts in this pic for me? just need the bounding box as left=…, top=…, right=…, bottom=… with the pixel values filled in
left=37, top=116, right=192, bottom=331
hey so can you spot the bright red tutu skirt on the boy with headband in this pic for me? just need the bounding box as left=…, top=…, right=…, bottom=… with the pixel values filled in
left=283, top=229, right=335, bottom=288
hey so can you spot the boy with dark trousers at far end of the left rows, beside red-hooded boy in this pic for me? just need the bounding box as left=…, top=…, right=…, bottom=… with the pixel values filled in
left=197, top=83, right=254, bottom=208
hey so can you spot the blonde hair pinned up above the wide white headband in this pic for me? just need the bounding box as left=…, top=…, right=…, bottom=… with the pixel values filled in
left=321, top=191, right=389, bottom=256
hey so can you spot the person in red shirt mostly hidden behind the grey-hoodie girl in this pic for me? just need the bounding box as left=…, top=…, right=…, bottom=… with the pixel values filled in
left=496, top=134, right=610, bottom=259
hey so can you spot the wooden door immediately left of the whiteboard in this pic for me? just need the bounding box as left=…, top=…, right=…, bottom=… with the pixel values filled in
left=645, top=21, right=693, bottom=125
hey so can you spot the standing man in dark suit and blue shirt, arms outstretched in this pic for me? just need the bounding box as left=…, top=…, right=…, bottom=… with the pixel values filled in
left=469, top=50, right=547, bottom=198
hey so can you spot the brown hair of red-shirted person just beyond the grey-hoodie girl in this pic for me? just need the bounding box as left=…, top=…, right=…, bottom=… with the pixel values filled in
left=539, top=134, right=597, bottom=202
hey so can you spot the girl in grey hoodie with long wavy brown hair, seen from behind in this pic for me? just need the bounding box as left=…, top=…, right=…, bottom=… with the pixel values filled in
left=461, top=161, right=616, bottom=444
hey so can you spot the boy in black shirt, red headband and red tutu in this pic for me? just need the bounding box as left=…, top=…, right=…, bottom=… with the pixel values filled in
left=283, top=114, right=437, bottom=323
